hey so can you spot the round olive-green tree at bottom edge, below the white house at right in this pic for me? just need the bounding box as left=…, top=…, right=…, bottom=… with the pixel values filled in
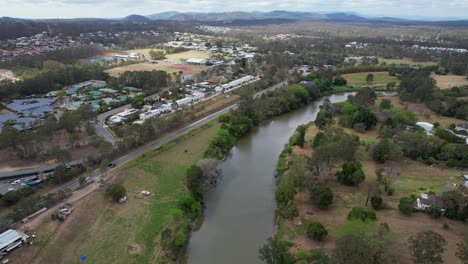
left=409, top=231, right=447, bottom=264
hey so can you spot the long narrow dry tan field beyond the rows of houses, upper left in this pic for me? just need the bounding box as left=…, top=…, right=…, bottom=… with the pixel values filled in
left=106, top=62, right=209, bottom=77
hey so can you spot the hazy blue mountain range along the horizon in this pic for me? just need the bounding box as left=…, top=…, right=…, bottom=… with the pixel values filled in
left=0, top=10, right=468, bottom=26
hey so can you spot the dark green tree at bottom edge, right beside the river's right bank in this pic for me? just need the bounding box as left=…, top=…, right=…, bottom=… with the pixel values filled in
left=259, top=236, right=294, bottom=264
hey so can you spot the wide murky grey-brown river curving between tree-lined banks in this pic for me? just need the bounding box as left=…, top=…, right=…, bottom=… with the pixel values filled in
left=187, top=93, right=351, bottom=264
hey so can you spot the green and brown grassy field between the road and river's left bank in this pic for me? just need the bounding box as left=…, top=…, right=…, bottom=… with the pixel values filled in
left=29, top=123, right=219, bottom=263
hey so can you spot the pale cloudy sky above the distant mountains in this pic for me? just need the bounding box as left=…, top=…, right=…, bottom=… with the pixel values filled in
left=0, top=0, right=468, bottom=19
